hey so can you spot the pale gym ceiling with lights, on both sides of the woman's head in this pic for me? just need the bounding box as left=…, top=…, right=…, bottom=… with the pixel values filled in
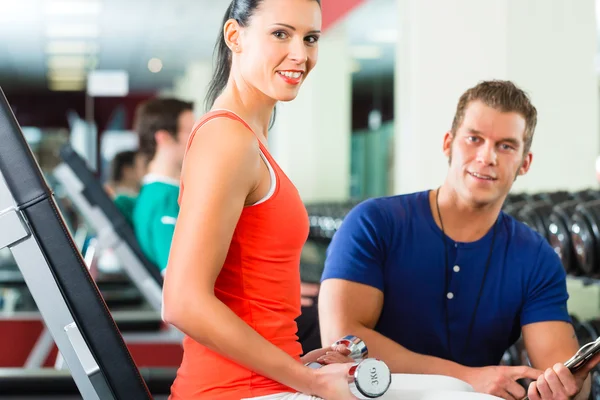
left=0, top=0, right=398, bottom=92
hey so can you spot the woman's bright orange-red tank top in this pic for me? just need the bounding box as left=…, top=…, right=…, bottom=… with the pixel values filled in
left=170, top=111, right=309, bottom=400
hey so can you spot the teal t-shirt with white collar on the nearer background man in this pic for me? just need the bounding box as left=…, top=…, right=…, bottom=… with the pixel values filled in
left=133, top=175, right=179, bottom=274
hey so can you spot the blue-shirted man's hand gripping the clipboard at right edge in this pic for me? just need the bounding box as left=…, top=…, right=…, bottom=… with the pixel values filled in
left=527, top=354, right=600, bottom=400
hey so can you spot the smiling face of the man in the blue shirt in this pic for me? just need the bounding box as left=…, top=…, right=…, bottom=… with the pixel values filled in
left=444, top=101, right=532, bottom=207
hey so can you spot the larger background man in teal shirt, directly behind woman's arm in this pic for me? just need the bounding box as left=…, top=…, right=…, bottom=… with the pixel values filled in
left=133, top=99, right=195, bottom=274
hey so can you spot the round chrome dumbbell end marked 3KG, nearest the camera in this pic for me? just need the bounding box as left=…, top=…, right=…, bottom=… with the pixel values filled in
left=307, top=358, right=392, bottom=399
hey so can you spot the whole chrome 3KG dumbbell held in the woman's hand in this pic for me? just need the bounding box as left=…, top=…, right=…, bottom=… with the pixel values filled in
left=307, top=336, right=392, bottom=399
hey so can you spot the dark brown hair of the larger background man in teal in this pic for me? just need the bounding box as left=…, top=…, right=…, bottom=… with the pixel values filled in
left=133, top=98, right=194, bottom=161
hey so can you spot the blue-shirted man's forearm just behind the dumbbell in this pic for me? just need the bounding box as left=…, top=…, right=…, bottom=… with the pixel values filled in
left=340, top=326, right=468, bottom=380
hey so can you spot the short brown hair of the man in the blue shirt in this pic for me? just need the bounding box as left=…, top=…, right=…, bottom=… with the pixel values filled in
left=452, top=80, right=537, bottom=154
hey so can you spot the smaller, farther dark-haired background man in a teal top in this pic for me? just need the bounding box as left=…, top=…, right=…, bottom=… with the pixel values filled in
left=106, top=150, right=145, bottom=225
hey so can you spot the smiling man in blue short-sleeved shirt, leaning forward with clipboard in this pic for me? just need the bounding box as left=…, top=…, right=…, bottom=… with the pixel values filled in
left=319, top=81, right=599, bottom=400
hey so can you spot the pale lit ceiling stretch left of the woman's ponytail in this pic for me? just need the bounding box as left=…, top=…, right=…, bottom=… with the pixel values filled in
left=0, top=0, right=227, bottom=91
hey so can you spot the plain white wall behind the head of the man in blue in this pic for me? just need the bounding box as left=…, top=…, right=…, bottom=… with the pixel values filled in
left=394, top=0, right=600, bottom=193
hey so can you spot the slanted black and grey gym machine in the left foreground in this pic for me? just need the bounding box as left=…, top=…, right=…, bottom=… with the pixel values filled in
left=0, top=88, right=173, bottom=400
